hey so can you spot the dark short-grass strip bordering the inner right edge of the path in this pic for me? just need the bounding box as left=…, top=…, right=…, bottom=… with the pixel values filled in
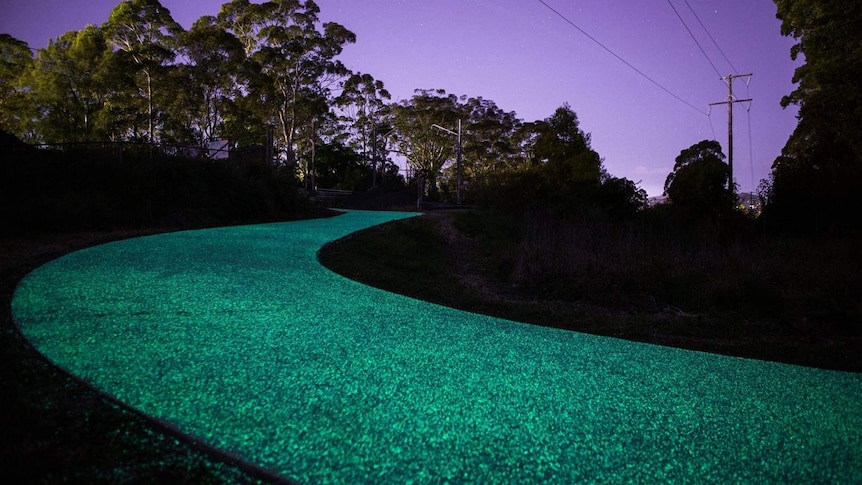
left=318, top=214, right=862, bottom=372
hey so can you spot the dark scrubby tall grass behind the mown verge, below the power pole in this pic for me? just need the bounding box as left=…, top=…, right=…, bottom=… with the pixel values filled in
left=492, top=206, right=862, bottom=335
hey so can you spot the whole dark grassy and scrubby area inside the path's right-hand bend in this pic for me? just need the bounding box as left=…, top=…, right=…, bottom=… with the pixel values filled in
left=319, top=208, right=862, bottom=372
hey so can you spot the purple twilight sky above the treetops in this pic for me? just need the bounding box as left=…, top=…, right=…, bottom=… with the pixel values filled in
left=0, top=0, right=800, bottom=196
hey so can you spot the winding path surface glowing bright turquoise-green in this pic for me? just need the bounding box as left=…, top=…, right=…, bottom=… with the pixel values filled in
left=8, top=212, right=862, bottom=484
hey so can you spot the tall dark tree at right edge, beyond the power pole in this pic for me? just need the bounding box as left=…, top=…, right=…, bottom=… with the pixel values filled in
left=763, top=0, right=862, bottom=232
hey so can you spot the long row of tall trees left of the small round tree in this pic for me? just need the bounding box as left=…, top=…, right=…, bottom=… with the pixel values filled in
left=0, top=0, right=645, bottom=212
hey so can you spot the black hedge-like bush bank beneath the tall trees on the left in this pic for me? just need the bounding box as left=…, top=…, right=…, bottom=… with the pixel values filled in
left=0, top=136, right=308, bottom=232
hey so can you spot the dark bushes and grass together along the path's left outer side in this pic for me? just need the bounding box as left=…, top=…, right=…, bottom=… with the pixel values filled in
left=0, top=132, right=324, bottom=483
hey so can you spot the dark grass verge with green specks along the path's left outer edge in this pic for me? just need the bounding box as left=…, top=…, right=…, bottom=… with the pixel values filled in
left=0, top=221, right=338, bottom=484
